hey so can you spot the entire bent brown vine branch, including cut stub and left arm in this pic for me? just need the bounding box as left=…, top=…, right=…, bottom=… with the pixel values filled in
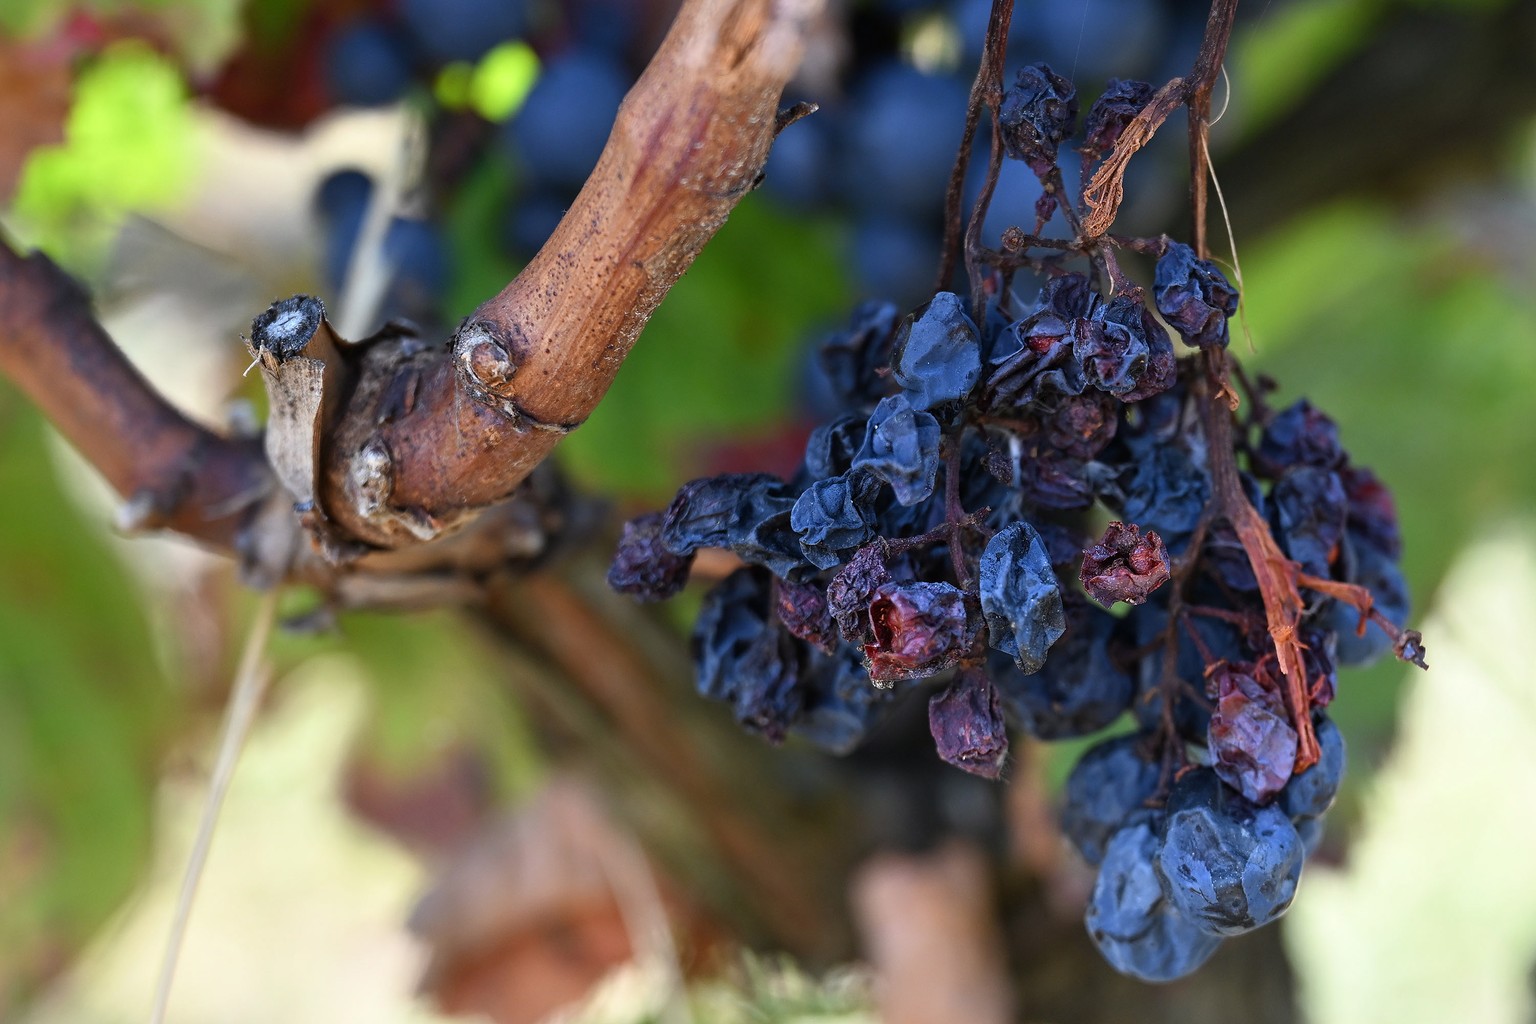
left=0, top=0, right=822, bottom=582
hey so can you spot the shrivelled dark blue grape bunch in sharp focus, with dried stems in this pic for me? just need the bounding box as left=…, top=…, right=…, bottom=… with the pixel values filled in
left=608, top=64, right=1422, bottom=981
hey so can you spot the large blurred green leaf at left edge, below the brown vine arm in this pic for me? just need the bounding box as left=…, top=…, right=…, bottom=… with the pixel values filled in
left=0, top=387, right=181, bottom=1013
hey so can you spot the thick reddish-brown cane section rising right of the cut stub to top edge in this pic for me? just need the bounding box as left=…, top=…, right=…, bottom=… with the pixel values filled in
left=311, top=0, right=820, bottom=548
